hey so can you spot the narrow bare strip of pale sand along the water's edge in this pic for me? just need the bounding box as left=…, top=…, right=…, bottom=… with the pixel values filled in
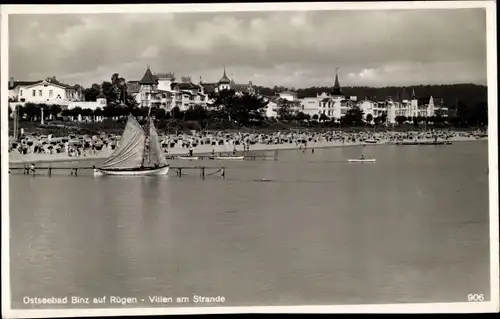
left=9, top=136, right=488, bottom=166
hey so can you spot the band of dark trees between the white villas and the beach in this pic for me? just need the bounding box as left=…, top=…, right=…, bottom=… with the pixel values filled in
left=9, top=90, right=488, bottom=130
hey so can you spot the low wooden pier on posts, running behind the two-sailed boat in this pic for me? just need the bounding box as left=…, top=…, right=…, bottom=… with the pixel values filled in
left=9, top=165, right=226, bottom=179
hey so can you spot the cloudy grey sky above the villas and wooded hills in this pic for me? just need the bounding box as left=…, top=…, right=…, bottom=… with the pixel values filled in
left=9, top=9, right=486, bottom=89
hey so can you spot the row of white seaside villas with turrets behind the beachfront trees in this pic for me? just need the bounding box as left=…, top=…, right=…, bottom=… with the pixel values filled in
left=9, top=66, right=448, bottom=124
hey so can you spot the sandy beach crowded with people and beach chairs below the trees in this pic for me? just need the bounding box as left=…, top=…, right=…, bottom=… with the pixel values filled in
left=9, top=130, right=487, bottom=164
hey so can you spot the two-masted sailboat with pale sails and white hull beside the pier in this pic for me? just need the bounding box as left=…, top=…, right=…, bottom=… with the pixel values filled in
left=94, top=114, right=170, bottom=176
